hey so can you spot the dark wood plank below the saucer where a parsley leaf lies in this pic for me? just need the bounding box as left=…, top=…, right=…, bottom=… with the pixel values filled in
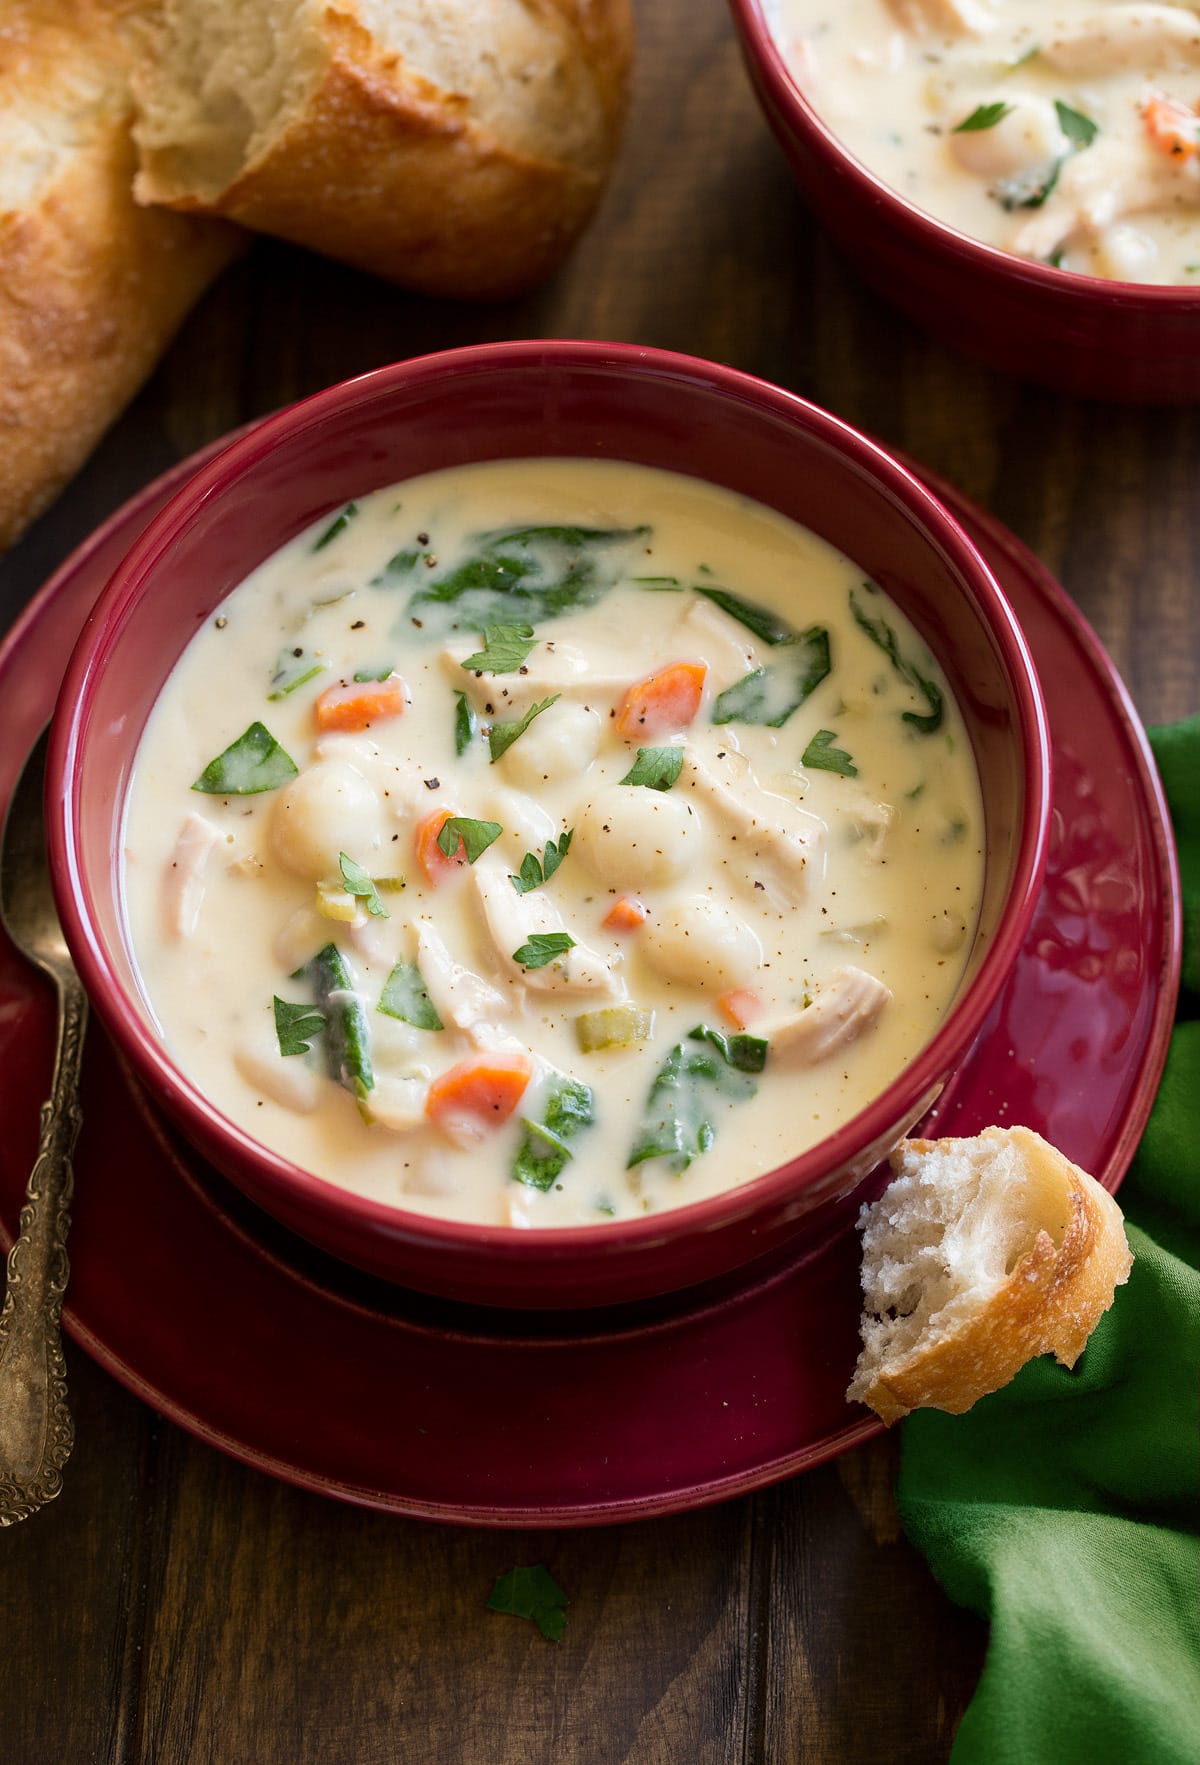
left=131, top=1433, right=748, bottom=1765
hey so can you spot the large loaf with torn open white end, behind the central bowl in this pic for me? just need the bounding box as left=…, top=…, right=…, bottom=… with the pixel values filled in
left=134, top=0, right=632, bottom=297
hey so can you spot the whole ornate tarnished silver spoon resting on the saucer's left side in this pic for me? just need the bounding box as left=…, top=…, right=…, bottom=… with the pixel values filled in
left=0, top=731, right=88, bottom=1527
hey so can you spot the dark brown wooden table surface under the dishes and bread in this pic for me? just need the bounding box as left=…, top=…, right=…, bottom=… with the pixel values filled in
left=0, top=0, right=1200, bottom=1765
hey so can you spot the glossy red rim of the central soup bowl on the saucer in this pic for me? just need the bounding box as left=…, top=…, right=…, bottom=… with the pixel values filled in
left=46, top=339, right=1050, bottom=1264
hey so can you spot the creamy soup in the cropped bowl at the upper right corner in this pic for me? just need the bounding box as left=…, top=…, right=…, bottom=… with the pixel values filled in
left=766, top=0, right=1200, bottom=286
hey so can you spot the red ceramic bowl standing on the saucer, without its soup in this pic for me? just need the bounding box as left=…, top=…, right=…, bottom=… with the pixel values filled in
left=48, top=342, right=1048, bottom=1308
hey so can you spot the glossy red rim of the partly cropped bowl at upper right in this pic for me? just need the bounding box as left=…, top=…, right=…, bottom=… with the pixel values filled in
left=729, top=0, right=1200, bottom=311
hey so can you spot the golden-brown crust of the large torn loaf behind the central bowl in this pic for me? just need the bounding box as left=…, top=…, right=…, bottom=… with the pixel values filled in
left=136, top=0, right=632, bottom=298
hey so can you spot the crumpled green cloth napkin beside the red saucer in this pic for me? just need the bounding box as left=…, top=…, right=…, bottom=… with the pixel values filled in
left=896, top=717, right=1200, bottom=1765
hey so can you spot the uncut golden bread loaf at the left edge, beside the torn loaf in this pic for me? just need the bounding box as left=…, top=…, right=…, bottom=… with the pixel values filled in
left=0, top=0, right=238, bottom=547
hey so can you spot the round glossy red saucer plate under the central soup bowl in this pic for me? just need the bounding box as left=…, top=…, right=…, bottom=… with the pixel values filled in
left=0, top=437, right=1179, bottom=1527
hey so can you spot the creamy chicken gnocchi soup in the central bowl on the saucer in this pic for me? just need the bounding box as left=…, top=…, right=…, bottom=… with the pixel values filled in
left=124, top=461, right=981, bottom=1227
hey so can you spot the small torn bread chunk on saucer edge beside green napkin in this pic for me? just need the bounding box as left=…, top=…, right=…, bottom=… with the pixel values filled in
left=847, top=1128, right=1133, bottom=1423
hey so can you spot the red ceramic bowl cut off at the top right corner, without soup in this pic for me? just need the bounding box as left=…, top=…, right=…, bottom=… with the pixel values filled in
left=729, top=0, right=1200, bottom=404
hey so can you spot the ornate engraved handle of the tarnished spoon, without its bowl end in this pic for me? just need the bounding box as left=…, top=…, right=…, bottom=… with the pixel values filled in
left=0, top=974, right=88, bottom=1527
